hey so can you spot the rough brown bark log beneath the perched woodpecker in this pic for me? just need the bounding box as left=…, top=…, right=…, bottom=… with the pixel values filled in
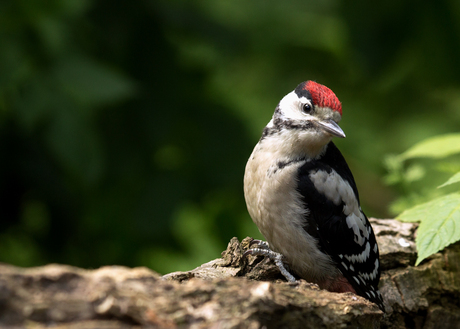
left=0, top=219, right=460, bottom=329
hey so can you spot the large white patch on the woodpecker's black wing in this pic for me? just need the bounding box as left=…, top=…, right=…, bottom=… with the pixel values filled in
left=309, top=170, right=370, bottom=246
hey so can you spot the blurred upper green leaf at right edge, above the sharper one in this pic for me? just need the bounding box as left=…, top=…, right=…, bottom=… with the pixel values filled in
left=399, top=134, right=460, bottom=160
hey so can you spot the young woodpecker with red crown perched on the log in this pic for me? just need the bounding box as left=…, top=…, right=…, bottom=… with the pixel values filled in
left=244, top=81, right=385, bottom=311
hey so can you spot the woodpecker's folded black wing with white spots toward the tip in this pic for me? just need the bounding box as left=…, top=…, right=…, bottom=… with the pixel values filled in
left=297, top=142, right=384, bottom=310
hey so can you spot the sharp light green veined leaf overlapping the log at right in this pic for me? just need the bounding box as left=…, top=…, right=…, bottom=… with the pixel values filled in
left=397, top=193, right=460, bottom=265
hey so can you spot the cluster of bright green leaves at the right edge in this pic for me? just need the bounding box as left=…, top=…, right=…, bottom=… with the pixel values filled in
left=386, top=133, right=460, bottom=265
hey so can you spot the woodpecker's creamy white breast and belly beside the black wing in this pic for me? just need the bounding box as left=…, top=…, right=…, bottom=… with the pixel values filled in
left=244, top=133, right=340, bottom=283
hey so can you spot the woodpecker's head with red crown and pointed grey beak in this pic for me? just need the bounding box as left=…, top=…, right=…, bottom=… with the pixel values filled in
left=264, top=81, right=345, bottom=155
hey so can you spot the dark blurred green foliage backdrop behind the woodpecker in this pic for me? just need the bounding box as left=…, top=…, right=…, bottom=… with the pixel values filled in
left=0, top=0, right=460, bottom=273
